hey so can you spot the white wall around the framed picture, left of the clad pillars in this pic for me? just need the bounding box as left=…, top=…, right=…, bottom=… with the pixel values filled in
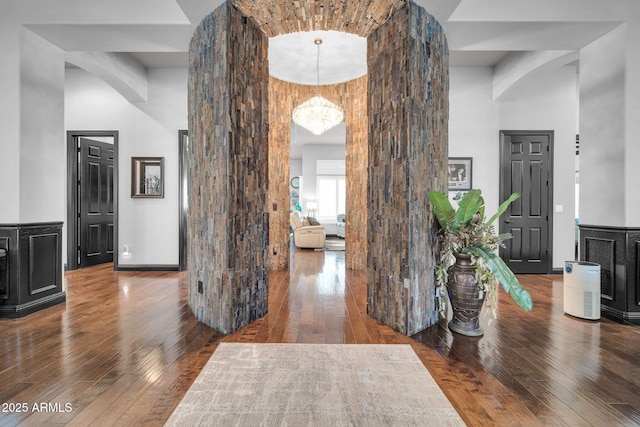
left=65, top=68, right=187, bottom=266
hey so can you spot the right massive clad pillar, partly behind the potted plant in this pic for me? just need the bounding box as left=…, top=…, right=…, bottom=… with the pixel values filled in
left=367, top=2, right=449, bottom=335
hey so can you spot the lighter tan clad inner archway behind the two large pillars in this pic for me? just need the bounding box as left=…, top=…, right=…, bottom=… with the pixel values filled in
left=269, top=76, right=367, bottom=270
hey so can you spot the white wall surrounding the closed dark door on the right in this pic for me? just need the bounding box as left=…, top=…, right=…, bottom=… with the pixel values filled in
left=449, top=67, right=578, bottom=269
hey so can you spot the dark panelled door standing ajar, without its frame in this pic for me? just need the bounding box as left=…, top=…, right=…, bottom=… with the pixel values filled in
left=78, top=138, right=114, bottom=267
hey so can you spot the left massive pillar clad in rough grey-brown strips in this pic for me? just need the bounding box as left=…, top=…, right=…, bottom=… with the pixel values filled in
left=188, top=4, right=269, bottom=333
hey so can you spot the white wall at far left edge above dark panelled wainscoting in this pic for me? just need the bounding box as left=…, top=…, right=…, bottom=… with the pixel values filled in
left=0, top=24, right=66, bottom=224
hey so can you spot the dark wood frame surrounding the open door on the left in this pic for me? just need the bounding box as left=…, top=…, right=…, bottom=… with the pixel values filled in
left=66, top=130, right=118, bottom=270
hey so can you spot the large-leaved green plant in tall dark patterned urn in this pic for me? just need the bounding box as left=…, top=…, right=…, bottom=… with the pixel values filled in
left=429, top=190, right=533, bottom=336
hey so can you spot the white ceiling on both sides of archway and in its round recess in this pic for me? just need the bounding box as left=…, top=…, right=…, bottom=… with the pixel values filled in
left=7, top=0, right=640, bottom=157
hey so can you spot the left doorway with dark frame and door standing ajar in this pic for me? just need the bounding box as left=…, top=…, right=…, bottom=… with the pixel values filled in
left=67, top=131, right=118, bottom=270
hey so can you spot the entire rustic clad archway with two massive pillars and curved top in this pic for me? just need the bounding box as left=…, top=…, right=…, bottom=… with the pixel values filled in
left=188, top=0, right=448, bottom=335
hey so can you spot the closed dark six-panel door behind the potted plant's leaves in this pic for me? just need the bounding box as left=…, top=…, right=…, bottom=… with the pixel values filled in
left=499, top=131, right=553, bottom=274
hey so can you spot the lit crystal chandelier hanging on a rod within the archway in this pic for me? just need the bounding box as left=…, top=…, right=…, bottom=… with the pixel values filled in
left=293, top=39, right=344, bottom=135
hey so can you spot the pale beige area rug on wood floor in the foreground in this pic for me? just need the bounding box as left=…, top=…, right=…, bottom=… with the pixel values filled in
left=165, top=343, right=465, bottom=427
